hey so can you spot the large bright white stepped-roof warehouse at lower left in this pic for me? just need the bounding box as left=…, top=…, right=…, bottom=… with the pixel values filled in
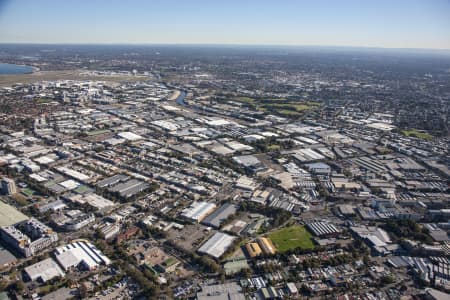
left=55, top=241, right=111, bottom=271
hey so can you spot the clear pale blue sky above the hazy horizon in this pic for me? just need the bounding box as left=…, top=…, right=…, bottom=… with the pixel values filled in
left=0, top=0, right=450, bottom=49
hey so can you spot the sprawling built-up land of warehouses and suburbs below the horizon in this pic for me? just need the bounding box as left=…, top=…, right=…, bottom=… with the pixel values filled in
left=0, top=45, right=450, bottom=300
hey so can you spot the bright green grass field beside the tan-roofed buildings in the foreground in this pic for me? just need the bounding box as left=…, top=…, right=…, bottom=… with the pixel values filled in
left=269, top=225, right=314, bottom=252
